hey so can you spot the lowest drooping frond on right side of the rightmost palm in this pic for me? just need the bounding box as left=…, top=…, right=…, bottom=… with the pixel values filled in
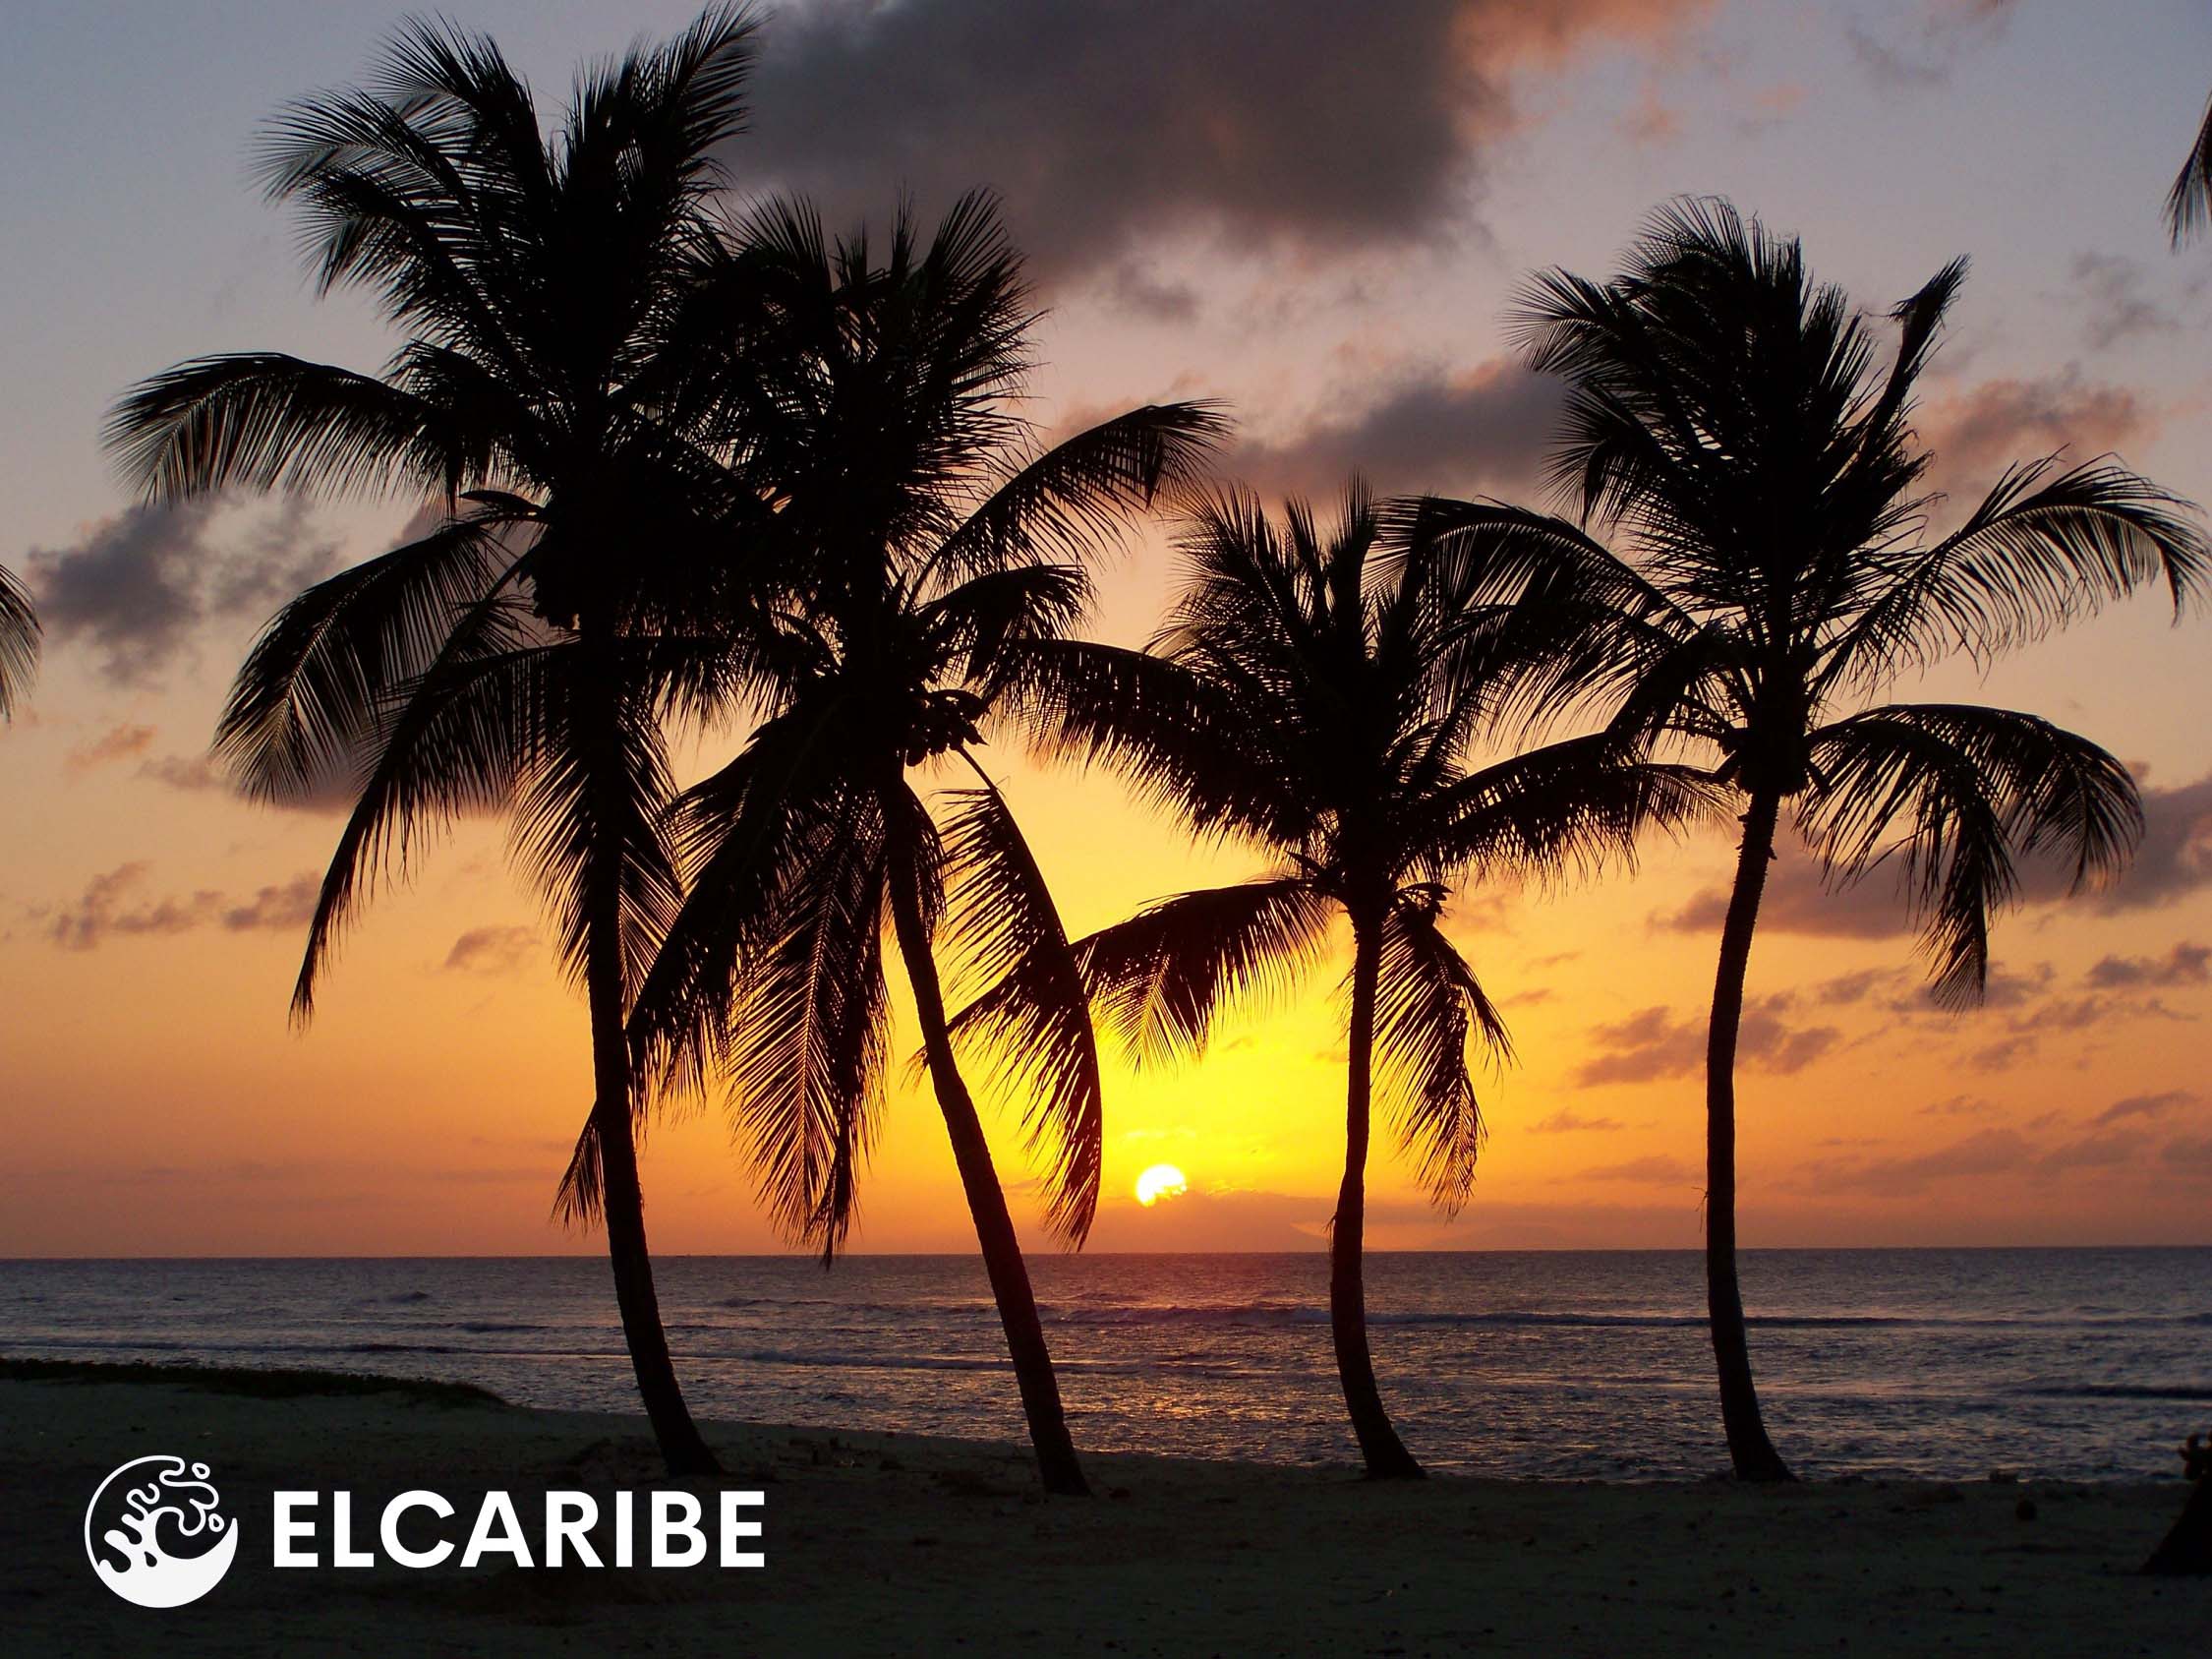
left=1798, top=703, right=2143, bottom=1006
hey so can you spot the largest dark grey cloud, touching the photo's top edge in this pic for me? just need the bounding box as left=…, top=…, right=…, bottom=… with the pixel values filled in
left=730, top=0, right=1706, bottom=278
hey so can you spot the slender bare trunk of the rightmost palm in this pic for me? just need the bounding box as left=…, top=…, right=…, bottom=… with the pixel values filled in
left=1706, top=795, right=1794, bottom=1480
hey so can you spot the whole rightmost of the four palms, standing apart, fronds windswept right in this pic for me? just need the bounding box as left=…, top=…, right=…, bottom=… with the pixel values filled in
left=1431, top=202, right=2205, bottom=1480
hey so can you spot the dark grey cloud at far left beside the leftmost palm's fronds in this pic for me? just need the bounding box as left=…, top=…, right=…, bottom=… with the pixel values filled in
left=25, top=498, right=338, bottom=685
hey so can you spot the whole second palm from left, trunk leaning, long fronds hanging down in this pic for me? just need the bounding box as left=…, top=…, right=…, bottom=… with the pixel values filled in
left=606, top=197, right=1223, bottom=1493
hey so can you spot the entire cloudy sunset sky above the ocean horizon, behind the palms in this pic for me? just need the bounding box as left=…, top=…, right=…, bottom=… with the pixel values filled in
left=0, top=0, right=2212, bottom=1254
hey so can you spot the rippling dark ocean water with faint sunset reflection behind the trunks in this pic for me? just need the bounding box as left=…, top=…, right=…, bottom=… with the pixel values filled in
left=0, top=1250, right=2212, bottom=1480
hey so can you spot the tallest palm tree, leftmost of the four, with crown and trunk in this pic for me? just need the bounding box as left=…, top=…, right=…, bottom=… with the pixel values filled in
left=111, top=7, right=779, bottom=1473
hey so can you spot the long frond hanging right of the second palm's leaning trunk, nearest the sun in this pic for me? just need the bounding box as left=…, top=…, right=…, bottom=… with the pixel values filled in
left=945, top=756, right=1106, bottom=1248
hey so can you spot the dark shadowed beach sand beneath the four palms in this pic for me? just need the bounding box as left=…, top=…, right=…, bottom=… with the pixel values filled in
left=0, top=1381, right=2212, bottom=1657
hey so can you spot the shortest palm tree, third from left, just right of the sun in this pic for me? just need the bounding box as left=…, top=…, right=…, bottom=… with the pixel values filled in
left=995, top=487, right=1704, bottom=1478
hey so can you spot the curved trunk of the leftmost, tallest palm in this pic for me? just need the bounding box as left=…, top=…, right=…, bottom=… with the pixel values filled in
left=584, top=689, right=722, bottom=1478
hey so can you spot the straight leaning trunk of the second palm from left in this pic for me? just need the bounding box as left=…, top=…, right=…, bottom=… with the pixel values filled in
left=892, top=822, right=1090, bottom=1498
